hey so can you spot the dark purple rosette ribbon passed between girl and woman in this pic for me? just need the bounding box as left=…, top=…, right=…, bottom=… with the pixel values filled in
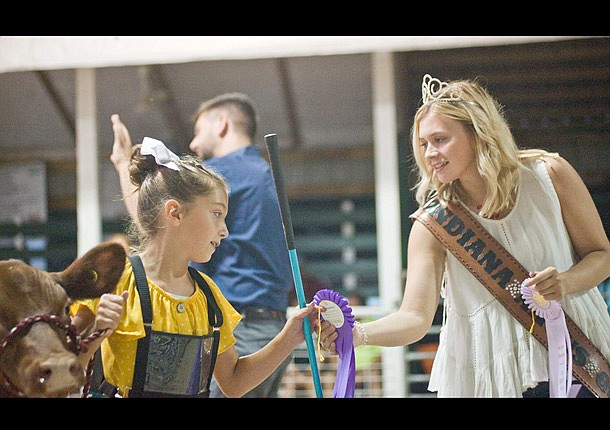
left=313, top=289, right=356, bottom=397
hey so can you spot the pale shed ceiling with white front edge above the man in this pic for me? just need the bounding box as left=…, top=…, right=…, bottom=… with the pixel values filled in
left=0, top=36, right=580, bottom=160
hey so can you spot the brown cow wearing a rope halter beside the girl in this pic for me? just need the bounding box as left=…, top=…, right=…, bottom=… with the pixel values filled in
left=0, top=242, right=125, bottom=397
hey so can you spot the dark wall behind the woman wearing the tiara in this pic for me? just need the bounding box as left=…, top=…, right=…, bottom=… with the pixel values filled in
left=397, top=38, right=610, bottom=268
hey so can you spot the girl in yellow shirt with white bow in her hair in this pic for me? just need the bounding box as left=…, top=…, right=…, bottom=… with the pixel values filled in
left=73, top=138, right=317, bottom=397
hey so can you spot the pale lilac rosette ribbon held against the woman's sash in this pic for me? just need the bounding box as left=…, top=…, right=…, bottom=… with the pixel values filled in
left=521, top=284, right=573, bottom=397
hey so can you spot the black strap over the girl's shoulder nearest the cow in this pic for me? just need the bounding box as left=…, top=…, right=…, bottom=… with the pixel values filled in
left=127, top=254, right=152, bottom=397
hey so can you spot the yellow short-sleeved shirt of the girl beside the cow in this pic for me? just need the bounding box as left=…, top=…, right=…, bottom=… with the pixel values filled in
left=73, top=260, right=241, bottom=397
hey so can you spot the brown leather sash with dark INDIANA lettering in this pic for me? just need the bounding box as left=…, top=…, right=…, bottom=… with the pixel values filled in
left=411, top=198, right=610, bottom=397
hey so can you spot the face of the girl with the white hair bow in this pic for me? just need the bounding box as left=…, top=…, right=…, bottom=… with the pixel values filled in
left=183, top=189, right=229, bottom=263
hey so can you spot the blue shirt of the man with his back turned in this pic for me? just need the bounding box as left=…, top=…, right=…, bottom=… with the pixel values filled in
left=191, top=145, right=294, bottom=311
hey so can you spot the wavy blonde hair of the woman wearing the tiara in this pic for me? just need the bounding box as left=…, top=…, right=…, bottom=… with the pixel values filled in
left=411, top=76, right=556, bottom=216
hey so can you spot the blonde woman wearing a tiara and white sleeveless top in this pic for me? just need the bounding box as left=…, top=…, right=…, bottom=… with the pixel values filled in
left=321, top=75, right=610, bottom=397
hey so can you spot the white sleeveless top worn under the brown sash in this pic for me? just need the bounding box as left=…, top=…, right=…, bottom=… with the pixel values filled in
left=428, top=160, right=610, bottom=397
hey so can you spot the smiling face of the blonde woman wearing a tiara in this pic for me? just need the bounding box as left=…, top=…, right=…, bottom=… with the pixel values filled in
left=419, top=111, right=478, bottom=184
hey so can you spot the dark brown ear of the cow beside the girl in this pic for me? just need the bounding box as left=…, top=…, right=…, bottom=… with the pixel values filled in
left=57, top=242, right=126, bottom=299
